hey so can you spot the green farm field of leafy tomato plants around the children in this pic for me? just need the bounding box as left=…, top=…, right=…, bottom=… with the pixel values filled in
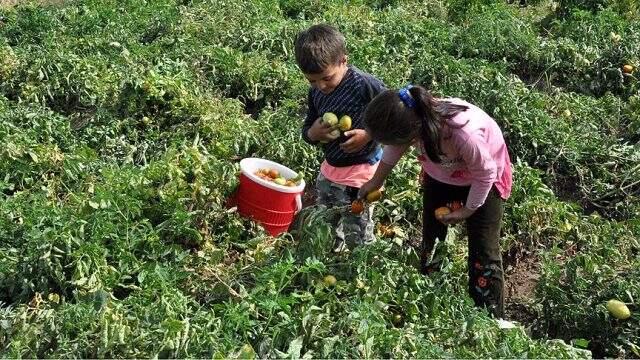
left=0, top=0, right=640, bottom=358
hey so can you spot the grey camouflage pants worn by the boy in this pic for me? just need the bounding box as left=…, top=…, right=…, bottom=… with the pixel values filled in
left=316, top=174, right=375, bottom=251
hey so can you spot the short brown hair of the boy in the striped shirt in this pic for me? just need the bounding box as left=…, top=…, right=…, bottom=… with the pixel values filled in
left=295, top=24, right=347, bottom=74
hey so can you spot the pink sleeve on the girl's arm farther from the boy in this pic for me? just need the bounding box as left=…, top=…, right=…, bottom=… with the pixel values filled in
left=459, top=134, right=498, bottom=210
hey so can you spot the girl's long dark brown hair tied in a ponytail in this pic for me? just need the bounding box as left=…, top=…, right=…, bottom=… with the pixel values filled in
left=364, top=86, right=468, bottom=163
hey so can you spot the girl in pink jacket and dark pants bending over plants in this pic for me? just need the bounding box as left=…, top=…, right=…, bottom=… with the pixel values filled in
left=358, top=86, right=512, bottom=318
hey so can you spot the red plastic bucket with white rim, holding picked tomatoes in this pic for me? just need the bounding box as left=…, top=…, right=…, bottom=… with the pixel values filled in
left=236, top=158, right=305, bottom=236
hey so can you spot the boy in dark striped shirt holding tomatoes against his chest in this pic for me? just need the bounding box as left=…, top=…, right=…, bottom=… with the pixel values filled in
left=295, top=24, right=386, bottom=252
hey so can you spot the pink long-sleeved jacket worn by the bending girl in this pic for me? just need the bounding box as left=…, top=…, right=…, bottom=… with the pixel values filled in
left=382, top=98, right=513, bottom=209
